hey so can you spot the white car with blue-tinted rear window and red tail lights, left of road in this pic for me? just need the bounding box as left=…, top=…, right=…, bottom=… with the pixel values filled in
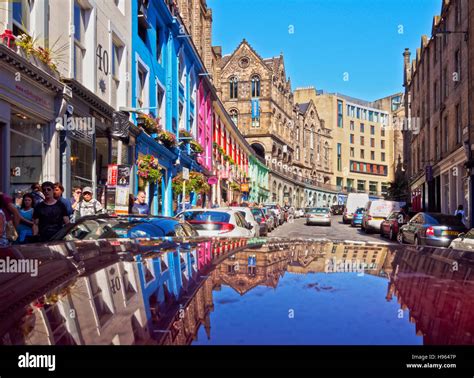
left=176, top=208, right=254, bottom=237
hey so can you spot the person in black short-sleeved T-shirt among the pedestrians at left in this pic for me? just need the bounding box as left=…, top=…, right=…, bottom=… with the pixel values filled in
left=33, top=181, right=69, bottom=242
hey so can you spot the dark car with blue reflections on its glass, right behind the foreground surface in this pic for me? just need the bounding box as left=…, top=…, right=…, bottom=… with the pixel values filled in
left=51, top=214, right=199, bottom=241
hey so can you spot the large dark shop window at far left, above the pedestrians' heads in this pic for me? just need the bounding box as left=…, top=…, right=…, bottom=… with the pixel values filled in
left=10, top=113, right=46, bottom=198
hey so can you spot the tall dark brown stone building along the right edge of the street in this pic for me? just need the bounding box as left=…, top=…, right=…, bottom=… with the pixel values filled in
left=403, top=0, right=472, bottom=222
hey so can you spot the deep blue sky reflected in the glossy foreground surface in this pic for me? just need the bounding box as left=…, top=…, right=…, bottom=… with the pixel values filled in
left=195, top=273, right=423, bottom=345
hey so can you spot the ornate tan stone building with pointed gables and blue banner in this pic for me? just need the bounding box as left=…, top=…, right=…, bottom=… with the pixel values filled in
left=214, top=39, right=337, bottom=207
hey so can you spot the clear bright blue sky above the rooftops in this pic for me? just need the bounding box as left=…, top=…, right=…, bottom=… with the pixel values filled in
left=207, top=0, right=441, bottom=101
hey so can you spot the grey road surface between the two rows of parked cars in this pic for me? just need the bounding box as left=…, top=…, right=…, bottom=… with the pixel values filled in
left=269, top=215, right=397, bottom=244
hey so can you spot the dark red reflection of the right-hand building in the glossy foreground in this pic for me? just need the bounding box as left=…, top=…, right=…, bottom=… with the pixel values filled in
left=386, top=248, right=474, bottom=345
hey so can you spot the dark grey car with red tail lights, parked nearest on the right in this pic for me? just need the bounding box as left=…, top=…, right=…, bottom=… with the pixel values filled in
left=397, top=213, right=467, bottom=247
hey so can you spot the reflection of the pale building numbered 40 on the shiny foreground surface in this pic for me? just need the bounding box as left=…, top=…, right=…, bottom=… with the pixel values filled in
left=1, top=261, right=149, bottom=345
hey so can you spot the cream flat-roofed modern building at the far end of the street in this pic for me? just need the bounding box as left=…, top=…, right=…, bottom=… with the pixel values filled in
left=295, top=87, right=395, bottom=202
